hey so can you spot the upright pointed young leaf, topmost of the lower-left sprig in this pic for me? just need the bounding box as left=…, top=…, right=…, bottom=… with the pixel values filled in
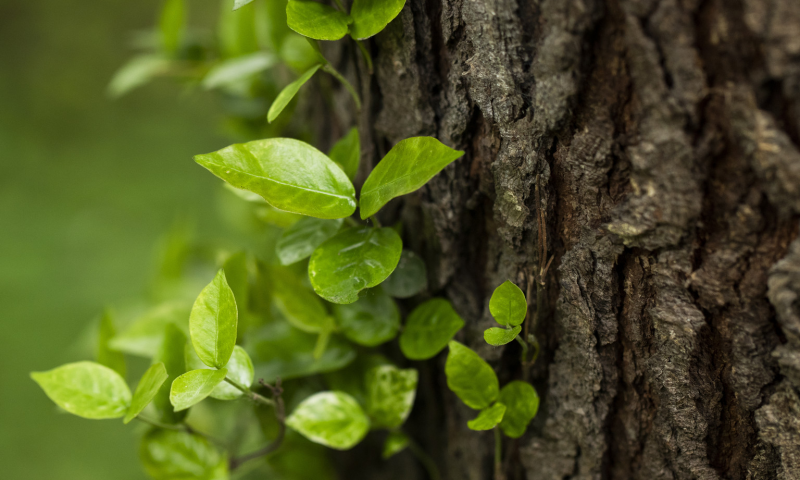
left=189, top=269, right=238, bottom=368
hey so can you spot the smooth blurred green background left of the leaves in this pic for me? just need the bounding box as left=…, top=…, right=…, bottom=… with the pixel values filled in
left=0, top=0, right=230, bottom=480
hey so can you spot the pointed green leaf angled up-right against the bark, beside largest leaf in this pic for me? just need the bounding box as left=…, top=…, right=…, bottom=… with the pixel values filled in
left=361, top=137, right=464, bottom=219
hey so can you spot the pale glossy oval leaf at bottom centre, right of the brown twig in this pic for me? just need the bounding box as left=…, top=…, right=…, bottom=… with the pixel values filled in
left=286, top=392, right=369, bottom=450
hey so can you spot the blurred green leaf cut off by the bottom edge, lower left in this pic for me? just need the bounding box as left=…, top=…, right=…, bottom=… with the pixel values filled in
left=139, top=428, right=228, bottom=480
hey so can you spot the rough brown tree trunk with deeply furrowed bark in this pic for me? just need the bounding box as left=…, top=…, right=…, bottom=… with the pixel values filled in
left=340, top=0, right=800, bottom=480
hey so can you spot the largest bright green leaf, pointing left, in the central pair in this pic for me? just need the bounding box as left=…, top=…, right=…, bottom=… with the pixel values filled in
left=195, top=138, right=356, bottom=218
